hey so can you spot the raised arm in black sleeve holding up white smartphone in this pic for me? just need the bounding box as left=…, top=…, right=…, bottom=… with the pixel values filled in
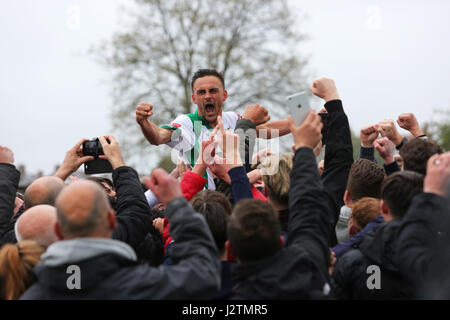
left=287, top=110, right=330, bottom=276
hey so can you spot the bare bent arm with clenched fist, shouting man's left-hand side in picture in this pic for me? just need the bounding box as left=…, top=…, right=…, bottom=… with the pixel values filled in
left=136, top=103, right=172, bottom=146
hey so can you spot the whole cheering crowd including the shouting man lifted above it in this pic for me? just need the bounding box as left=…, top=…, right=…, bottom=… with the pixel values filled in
left=0, top=69, right=450, bottom=300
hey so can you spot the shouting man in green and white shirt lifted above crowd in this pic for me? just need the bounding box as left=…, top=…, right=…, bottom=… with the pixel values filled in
left=136, top=69, right=290, bottom=188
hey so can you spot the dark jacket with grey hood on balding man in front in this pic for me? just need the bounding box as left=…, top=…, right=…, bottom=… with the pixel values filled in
left=21, top=198, right=220, bottom=300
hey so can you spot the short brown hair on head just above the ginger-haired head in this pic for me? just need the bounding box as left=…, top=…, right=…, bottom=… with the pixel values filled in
left=347, top=159, right=385, bottom=201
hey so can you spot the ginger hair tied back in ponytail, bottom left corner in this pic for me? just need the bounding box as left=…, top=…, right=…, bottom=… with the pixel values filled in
left=0, top=240, right=45, bottom=300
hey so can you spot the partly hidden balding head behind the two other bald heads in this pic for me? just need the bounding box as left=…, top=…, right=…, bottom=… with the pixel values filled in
left=24, top=176, right=65, bottom=209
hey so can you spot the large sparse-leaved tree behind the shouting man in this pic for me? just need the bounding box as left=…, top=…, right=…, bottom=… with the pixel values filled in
left=93, top=0, right=307, bottom=168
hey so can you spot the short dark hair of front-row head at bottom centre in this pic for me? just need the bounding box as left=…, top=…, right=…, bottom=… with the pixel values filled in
left=228, top=199, right=281, bottom=262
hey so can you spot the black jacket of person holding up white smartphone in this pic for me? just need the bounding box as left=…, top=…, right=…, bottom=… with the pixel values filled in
left=232, top=148, right=330, bottom=299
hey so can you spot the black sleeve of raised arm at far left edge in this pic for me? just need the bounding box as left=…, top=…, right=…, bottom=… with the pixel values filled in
left=0, top=163, right=20, bottom=244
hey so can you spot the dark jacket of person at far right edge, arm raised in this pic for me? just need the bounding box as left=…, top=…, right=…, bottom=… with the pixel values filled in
left=398, top=193, right=450, bottom=300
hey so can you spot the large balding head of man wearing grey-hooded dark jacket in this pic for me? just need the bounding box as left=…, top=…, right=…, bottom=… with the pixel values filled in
left=56, top=180, right=113, bottom=239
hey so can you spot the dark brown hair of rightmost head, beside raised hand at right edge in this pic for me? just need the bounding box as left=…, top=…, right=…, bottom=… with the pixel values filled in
left=400, top=138, right=442, bottom=175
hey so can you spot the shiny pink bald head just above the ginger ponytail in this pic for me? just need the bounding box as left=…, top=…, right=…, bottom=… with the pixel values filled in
left=15, top=204, right=58, bottom=247
